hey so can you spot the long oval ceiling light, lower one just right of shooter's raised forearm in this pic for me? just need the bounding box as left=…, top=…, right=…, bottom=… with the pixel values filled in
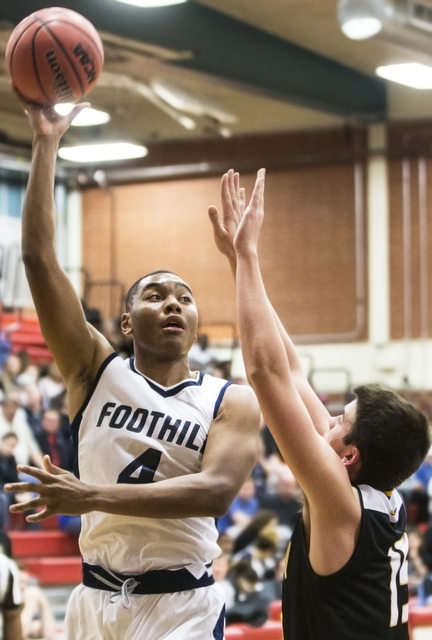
left=58, top=142, right=148, bottom=163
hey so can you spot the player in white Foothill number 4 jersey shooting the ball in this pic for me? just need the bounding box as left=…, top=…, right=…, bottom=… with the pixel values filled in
left=5, top=105, right=259, bottom=640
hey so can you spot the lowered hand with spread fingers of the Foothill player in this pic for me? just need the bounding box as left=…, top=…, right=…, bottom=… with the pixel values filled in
left=4, top=456, right=91, bottom=522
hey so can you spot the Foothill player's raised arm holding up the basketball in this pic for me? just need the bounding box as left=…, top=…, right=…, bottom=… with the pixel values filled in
left=22, top=104, right=112, bottom=406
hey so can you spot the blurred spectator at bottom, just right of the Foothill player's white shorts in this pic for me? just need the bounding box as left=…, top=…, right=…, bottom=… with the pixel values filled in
left=226, top=562, right=270, bottom=627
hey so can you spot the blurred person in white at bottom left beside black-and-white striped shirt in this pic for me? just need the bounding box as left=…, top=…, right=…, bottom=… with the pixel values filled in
left=19, top=569, right=56, bottom=640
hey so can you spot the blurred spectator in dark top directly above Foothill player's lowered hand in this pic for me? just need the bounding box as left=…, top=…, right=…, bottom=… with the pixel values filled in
left=36, top=409, right=74, bottom=471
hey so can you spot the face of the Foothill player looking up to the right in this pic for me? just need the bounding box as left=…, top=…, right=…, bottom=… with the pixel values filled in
left=125, top=273, right=198, bottom=358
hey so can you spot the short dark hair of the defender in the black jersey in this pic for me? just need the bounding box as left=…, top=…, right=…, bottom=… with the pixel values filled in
left=344, top=384, right=431, bottom=491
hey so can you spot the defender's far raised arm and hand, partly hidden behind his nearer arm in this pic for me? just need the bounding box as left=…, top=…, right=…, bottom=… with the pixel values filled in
left=209, top=169, right=330, bottom=435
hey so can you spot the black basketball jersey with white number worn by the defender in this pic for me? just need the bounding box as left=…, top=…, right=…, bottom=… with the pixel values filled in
left=282, top=485, right=409, bottom=640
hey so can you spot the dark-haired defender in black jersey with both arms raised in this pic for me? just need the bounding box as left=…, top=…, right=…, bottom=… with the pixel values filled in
left=209, top=169, right=430, bottom=640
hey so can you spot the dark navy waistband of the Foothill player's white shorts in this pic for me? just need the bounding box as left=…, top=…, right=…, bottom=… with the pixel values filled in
left=83, top=562, right=214, bottom=595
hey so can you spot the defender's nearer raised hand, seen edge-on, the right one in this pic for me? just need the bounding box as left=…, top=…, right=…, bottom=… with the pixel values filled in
left=233, top=169, right=265, bottom=255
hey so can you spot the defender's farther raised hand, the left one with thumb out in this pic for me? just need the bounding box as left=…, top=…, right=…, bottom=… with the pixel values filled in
left=208, top=169, right=245, bottom=264
